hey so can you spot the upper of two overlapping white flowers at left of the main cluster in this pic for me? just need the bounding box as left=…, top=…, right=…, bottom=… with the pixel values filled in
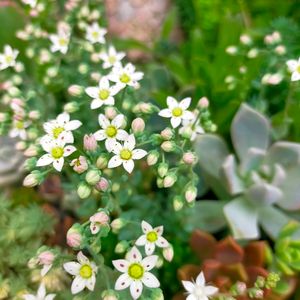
left=41, top=112, right=82, bottom=144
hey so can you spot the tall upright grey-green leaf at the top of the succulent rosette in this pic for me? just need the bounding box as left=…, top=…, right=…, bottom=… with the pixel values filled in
left=231, top=104, right=270, bottom=161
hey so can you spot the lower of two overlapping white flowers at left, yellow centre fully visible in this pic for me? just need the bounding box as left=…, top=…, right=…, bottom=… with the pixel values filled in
left=36, top=139, right=76, bottom=172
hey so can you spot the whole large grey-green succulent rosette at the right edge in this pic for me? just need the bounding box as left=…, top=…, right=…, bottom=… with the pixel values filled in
left=195, top=104, right=300, bottom=239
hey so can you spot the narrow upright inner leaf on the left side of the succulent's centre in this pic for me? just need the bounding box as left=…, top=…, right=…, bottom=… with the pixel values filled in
left=220, top=155, right=244, bottom=195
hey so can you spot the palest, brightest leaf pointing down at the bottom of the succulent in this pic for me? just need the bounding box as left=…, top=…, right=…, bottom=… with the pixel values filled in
left=224, top=198, right=259, bottom=239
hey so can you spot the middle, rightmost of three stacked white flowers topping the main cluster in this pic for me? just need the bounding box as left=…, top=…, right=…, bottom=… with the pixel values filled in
left=108, top=64, right=144, bottom=89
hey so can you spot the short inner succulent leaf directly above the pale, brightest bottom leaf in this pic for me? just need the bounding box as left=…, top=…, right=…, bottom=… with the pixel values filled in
left=245, top=182, right=283, bottom=206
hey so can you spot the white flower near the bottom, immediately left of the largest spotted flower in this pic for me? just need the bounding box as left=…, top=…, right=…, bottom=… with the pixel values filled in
left=64, top=251, right=97, bottom=294
